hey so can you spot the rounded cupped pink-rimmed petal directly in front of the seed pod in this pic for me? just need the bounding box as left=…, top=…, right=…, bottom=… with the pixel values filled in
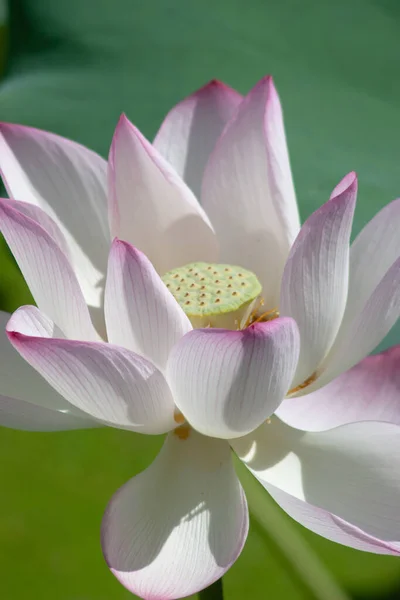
left=168, top=319, right=299, bottom=438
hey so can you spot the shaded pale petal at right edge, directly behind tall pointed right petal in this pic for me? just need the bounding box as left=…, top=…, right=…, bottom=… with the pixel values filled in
left=341, top=198, right=400, bottom=336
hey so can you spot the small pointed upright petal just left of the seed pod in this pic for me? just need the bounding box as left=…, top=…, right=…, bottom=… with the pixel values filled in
left=105, top=239, right=192, bottom=370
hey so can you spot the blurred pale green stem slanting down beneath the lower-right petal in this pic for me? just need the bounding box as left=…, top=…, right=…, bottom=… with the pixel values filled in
left=237, top=461, right=349, bottom=600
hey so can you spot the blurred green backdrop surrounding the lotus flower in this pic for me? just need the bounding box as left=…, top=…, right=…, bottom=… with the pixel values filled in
left=0, top=0, right=400, bottom=600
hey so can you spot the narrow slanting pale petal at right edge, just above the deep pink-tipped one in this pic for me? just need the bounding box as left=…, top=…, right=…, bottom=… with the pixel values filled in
left=318, top=258, right=400, bottom=392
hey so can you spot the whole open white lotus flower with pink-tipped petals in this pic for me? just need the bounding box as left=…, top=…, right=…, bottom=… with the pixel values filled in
left=0, top=77, right=400, bottom=599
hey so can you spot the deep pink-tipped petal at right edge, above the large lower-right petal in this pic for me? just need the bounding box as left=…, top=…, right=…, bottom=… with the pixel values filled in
left=276, top=345, right=400, bottom=431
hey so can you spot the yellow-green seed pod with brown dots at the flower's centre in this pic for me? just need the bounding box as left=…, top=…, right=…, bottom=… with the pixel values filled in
left=162, top=262, right=262, bottom=329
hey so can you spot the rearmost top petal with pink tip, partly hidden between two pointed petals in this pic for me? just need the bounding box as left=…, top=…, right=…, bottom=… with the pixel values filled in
left=153, top=79, right=242, bottom=198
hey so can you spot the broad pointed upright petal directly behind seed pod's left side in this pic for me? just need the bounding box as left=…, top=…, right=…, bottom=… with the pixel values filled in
left=109, top=115, right=217, bottom=273
